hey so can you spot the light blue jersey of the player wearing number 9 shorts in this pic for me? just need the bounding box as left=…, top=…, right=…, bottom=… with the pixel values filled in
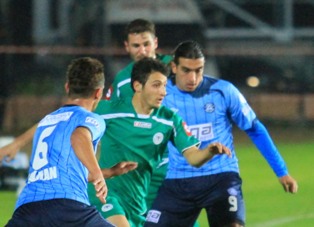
left=163, top=76, right=256, bottom=178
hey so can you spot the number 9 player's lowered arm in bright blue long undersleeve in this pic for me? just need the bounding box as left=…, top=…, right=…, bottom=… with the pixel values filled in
left=245, top=119, right=298, bottom=193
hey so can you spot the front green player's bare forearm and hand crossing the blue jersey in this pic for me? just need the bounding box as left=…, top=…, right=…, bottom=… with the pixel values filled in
left=183, top=143, right=231, bottom=168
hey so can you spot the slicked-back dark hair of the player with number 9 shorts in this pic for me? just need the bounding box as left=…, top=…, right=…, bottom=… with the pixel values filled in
left=173, top=40, right=204, bottom=64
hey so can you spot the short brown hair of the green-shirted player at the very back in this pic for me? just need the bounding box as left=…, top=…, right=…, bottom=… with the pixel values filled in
left=124, top=18, right=156, bottom=40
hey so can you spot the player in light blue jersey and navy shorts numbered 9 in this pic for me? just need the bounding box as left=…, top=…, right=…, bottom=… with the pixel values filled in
left=145, top=41, right=298, bottom=227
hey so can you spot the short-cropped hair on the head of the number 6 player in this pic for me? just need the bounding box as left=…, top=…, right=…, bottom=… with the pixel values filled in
left=66, top=57, right=105, bottom=98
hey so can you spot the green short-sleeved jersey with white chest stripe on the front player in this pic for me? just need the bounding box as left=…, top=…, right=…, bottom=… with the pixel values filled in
left=92, top=99, right=199, bottom=213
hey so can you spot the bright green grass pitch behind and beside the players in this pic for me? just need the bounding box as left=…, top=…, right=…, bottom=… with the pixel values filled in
left=0, top=127, right=314, bottom=227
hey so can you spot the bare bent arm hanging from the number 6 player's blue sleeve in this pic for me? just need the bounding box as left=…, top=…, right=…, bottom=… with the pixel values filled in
left=71, top=127, right=108, bottom=203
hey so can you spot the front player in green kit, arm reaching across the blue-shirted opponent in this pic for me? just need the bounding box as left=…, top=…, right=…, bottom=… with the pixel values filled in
left=89, top=58, right=230, bottom=227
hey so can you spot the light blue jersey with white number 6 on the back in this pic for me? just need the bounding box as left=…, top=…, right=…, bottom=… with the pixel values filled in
left=16, top=105, right=105, bottom=208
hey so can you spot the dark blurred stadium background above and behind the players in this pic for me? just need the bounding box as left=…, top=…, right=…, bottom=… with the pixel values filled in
left=0, top=0, right=314, bottom=135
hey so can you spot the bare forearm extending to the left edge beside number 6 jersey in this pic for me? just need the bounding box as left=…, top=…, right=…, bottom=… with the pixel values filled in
left=0, top=124, right=38, bottom=161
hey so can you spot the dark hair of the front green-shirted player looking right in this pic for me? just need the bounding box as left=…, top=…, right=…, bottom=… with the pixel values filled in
left=131, top=58, right=169, bottom=91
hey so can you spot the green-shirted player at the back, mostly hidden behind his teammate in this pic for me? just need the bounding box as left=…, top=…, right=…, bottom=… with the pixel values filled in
left=106, top=18, right=172, bottom=213
